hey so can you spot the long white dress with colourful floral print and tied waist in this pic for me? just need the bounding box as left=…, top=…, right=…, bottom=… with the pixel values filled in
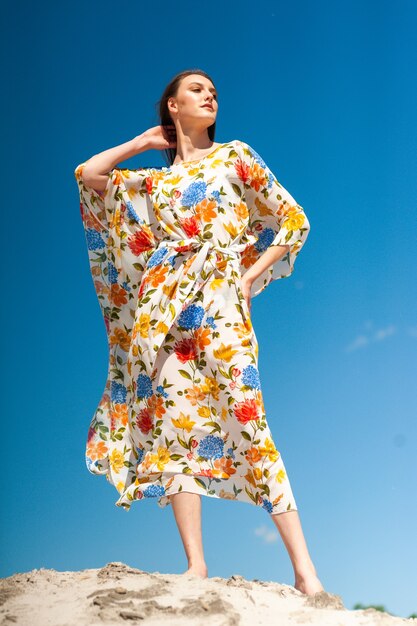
left=75, top=140, right=310, bottom=514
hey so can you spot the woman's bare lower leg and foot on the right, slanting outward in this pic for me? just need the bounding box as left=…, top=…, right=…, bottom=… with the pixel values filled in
left=271, top=509, right=323, bottom=595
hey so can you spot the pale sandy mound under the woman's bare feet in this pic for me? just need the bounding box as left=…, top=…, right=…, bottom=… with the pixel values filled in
left=0, top=562, right=417, bottom=626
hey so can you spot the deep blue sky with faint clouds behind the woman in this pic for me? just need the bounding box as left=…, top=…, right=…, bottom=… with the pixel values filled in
left=0, top=0, right=417, bottom=616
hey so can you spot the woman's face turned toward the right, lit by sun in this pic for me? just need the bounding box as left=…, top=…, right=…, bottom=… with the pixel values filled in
left=168, top=74, right=218, bottom=128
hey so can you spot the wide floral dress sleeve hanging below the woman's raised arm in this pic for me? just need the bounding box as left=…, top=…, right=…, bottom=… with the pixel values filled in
left=74, top=162, right=156, bottom=341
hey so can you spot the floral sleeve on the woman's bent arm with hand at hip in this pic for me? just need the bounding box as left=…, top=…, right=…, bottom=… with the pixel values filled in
left=234, top=141, right=310, bottom=296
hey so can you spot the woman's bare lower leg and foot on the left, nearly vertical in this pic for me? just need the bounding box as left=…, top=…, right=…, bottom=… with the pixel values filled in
left=170, top=491, right=208, bottom=578
